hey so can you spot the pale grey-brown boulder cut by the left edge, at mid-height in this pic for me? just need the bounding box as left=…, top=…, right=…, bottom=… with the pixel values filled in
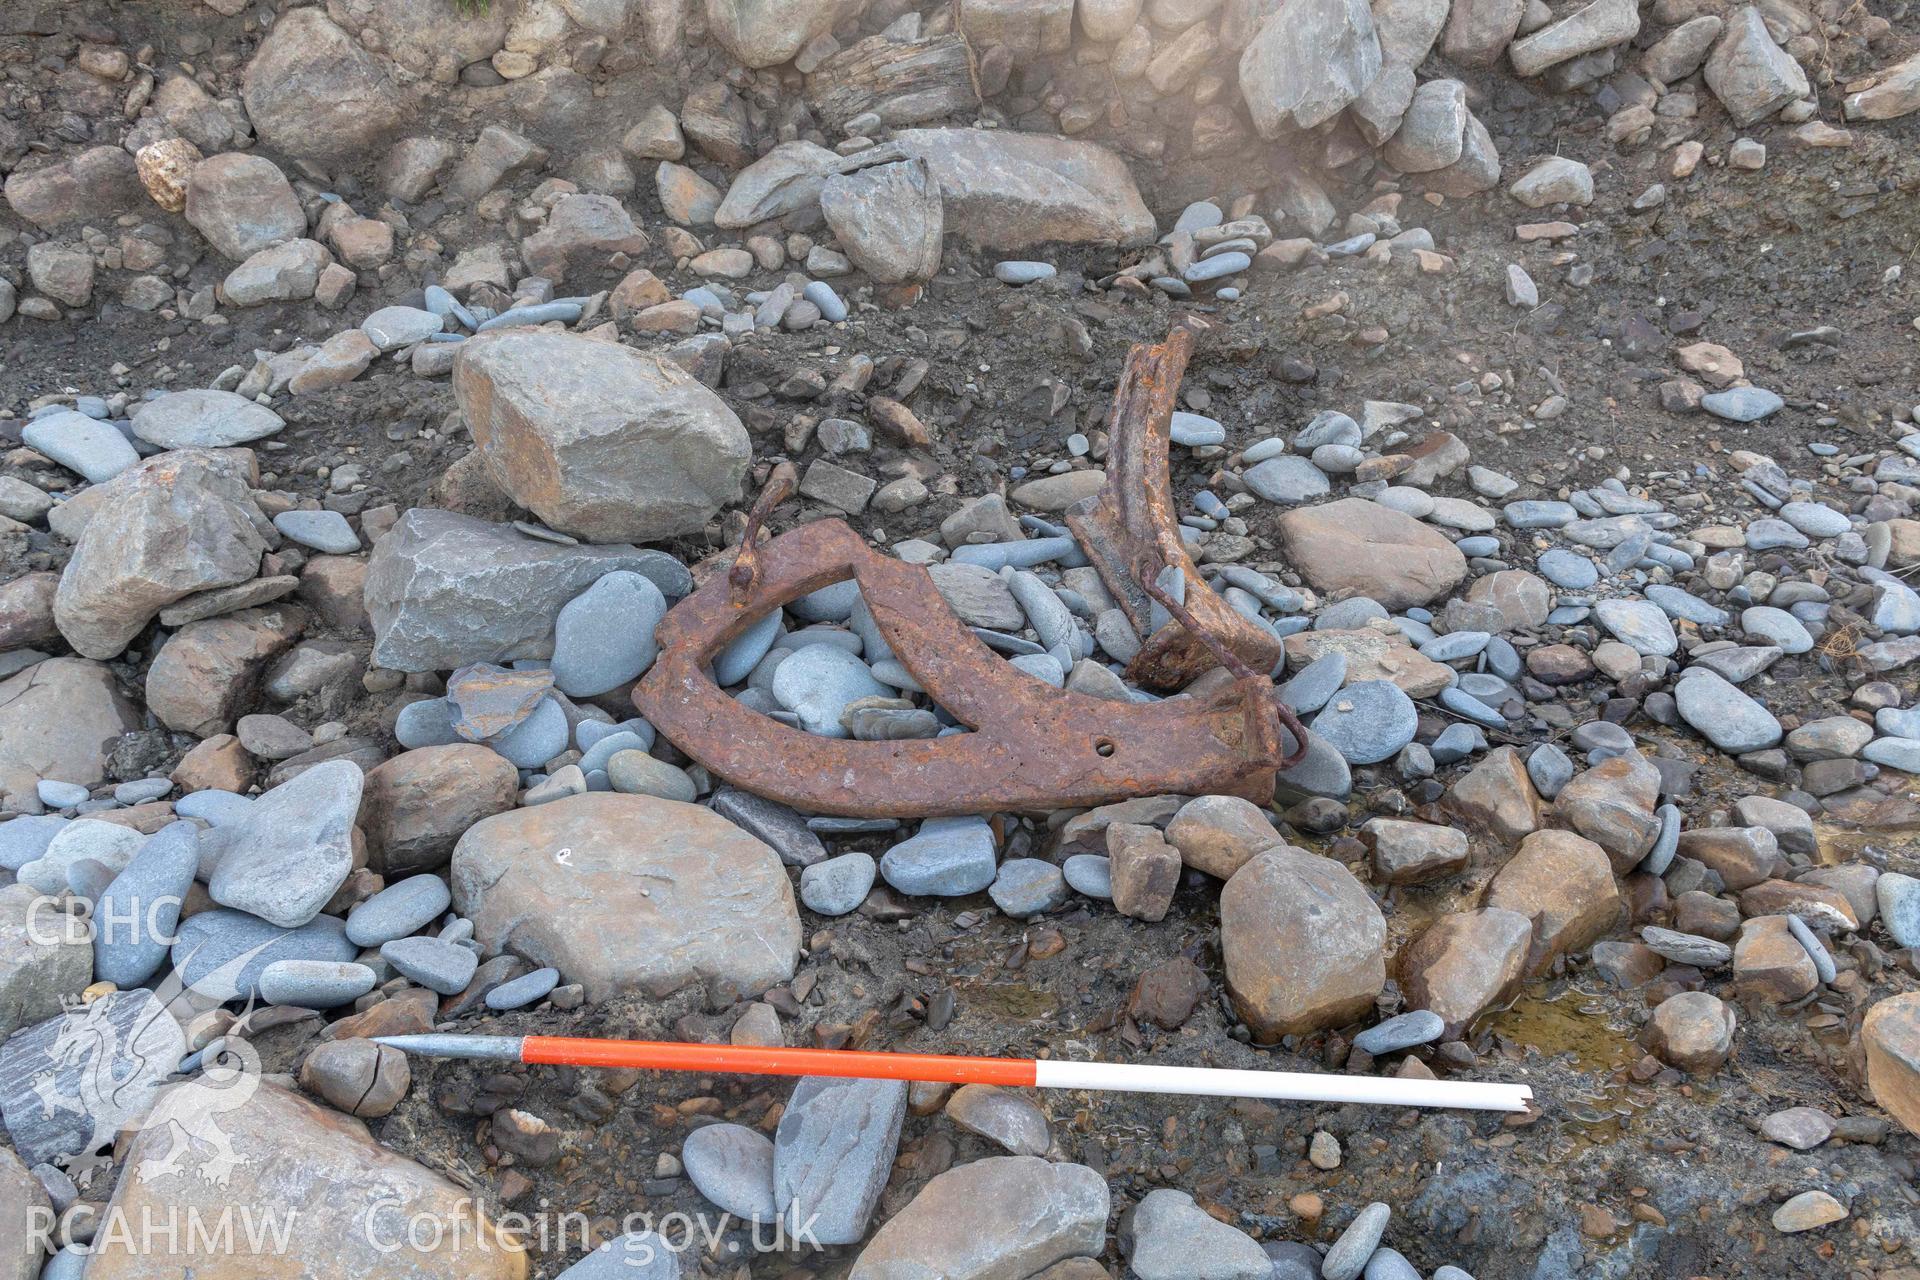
left=0, top=658, right=140, bottom=802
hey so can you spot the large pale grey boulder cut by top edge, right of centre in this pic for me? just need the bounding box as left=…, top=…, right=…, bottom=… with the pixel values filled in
left=1240, top=0, right=1380, bottom=138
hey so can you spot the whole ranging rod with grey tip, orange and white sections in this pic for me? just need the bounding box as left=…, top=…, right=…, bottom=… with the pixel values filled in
left=374, top=1034, right=1534, bottom=1111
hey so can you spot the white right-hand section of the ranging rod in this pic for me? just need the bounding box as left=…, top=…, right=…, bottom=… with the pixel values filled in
left=1033, top=1057, right=1534, bottom=1111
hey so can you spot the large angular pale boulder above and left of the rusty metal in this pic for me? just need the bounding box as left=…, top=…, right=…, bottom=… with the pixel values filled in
left=453, top=330, right=753, bottom=543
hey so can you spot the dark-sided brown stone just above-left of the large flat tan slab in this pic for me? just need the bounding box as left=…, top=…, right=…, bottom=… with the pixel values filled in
left=359, top=743, right=520, bottom=881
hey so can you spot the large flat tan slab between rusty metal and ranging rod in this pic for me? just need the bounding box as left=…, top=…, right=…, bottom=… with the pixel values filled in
left=453, top=793, right=801, bottom=1000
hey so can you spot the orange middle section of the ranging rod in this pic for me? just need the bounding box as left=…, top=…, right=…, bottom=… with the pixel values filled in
left=520, top=1036, right=1035, bottom=1088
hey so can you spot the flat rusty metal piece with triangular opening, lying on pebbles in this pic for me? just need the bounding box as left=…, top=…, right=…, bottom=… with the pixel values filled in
left=634, top=520, right=1292, bottom=818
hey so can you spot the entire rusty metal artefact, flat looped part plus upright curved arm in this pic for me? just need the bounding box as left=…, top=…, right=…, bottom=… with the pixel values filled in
left=634, top=332, right=1306, bottom=818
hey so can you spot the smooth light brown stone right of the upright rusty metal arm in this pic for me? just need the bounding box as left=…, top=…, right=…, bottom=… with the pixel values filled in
left=1279, top=497, right=1467, bottom=610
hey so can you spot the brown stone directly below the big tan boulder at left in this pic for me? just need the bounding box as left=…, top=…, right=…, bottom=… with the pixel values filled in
left=146, top=604, right=307, bottom=737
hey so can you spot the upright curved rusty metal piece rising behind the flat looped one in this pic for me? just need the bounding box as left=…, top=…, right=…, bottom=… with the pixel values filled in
left=1068, top=326, right=1281, bottom=691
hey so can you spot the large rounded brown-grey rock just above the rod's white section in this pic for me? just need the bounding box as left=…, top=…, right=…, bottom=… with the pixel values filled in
left=1219, top=846, right=1386, bottom=1044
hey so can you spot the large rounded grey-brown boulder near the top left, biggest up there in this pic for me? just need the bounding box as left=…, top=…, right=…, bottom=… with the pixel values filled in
left=240, top=8, right=407, bottom=165
